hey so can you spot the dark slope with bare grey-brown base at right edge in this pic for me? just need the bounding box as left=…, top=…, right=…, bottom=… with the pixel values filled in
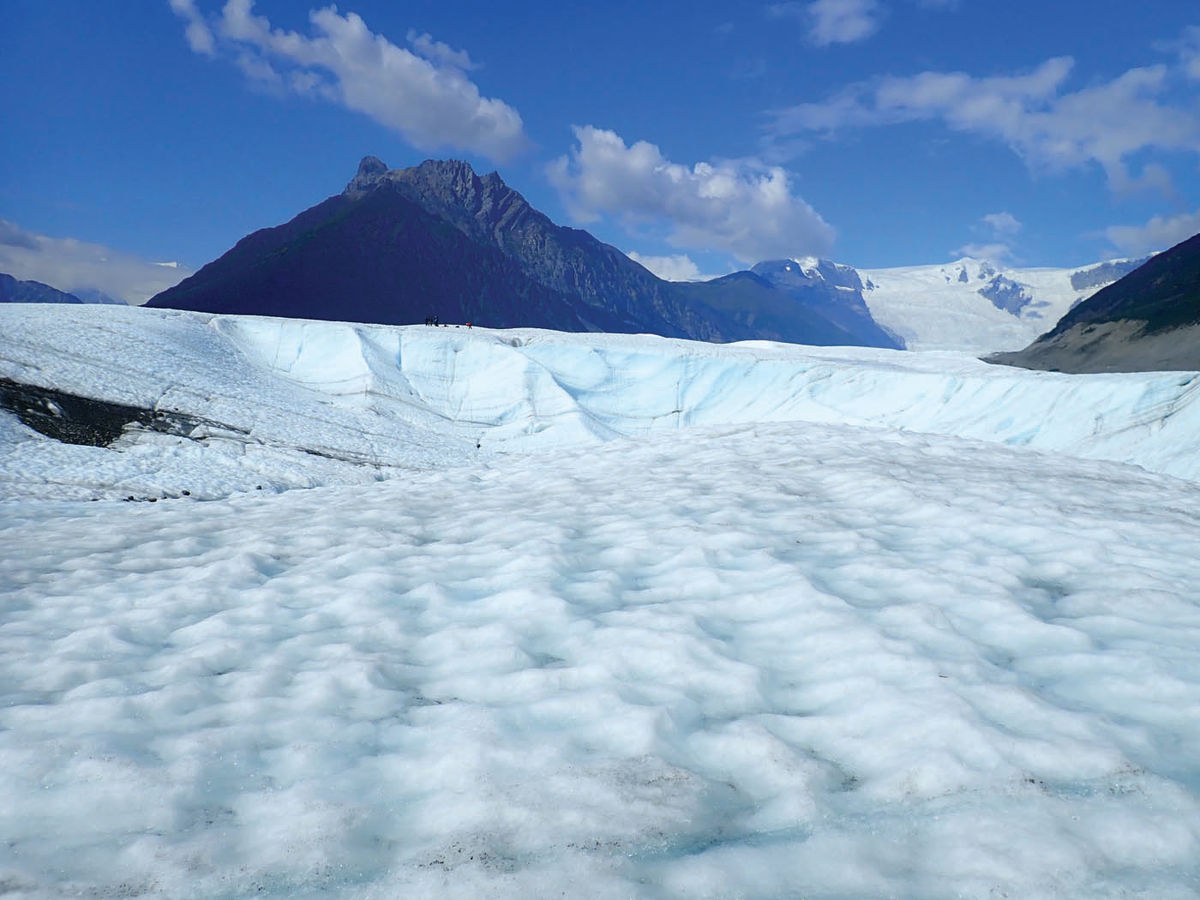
left=988, top=234, right=1200, bottom=372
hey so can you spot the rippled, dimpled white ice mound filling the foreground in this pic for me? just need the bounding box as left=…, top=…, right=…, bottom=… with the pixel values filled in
left=0, top=425, right=1200, bottom=898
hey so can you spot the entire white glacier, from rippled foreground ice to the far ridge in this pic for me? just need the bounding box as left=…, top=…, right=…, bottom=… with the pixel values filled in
left=0, top=307, right=1200, bottom=898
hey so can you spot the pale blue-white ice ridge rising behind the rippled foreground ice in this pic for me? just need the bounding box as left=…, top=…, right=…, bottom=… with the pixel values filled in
left=0, top=306, right=1200, bottom=496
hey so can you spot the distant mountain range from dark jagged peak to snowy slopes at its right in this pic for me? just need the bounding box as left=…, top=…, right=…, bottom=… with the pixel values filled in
left=133, top=156, right=1141, bottom=355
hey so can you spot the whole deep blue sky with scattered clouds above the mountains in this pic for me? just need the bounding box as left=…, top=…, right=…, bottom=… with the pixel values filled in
left=0, top=0, right=1200, bottom=296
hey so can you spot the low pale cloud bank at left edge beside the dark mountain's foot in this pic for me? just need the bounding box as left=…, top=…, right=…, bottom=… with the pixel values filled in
left=0, top=220, right=192, bottom=305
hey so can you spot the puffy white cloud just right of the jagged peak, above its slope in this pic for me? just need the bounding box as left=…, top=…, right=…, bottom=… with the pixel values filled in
left=548, top=126, right=834, bottom=262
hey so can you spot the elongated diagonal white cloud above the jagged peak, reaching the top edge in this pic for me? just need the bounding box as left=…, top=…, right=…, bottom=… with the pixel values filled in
left=169, top=0, right=529, bottom=161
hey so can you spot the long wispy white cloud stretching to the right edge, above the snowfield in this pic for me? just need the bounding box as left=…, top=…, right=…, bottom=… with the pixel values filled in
left=772, top=56, right=1200, bottom=191
